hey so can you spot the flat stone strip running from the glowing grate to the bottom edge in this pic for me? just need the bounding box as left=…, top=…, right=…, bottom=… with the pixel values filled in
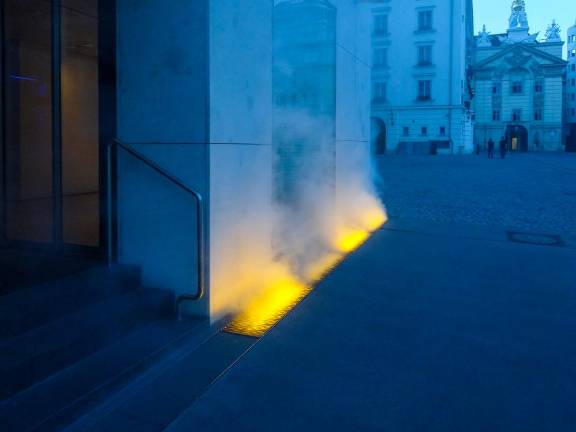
left=65, top=332, right=257, bottom=432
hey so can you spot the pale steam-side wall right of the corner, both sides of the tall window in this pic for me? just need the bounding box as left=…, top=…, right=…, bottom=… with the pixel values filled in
left=209, top=0, right=370, bottom=317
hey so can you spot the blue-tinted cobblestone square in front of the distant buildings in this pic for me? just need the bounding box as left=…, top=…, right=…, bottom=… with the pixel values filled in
left=377, top=153, right=576, bottom=234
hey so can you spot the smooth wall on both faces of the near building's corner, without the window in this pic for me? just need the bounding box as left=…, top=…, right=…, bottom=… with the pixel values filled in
left=118, top=0, right=370, bottom=318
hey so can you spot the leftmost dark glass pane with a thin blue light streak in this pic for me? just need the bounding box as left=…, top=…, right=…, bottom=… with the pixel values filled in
left=3, top=0, right=53, bottom=242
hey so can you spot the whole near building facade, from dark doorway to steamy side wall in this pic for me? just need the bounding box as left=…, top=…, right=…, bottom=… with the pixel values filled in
left=0, top=0, right=378, bottom=317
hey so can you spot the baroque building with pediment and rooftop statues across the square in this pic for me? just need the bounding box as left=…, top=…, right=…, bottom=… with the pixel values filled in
left=473, top=0, right=566, bottom=151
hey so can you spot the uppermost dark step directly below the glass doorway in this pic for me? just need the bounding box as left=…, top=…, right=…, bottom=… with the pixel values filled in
left=0, top=265, right=140, bottom=342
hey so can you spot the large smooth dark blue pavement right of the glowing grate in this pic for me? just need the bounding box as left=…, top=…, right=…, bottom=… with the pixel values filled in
left=164, top=220, right=576, bottom=432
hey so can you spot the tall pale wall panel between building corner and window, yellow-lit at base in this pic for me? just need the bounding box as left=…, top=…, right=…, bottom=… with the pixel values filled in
left=209, top=0, right=273, bottom=317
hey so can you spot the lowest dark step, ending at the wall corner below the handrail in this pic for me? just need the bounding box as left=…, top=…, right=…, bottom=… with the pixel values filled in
left=0, top=318, right=205, bottom=432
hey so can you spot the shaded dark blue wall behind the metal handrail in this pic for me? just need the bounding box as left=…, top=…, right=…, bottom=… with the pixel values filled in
left=117, top=0, right=208, bottom=315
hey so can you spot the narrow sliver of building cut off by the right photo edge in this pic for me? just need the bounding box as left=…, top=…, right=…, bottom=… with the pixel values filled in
left=564, top=24, right=576, bottom=151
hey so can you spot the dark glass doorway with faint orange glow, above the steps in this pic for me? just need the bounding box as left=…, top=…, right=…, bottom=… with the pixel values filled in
left=0, top=0, right=115, bottom=254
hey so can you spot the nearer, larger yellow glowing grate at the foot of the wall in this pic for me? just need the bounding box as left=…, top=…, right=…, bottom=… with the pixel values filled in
left=225, top=276, right=310, bottom=337
